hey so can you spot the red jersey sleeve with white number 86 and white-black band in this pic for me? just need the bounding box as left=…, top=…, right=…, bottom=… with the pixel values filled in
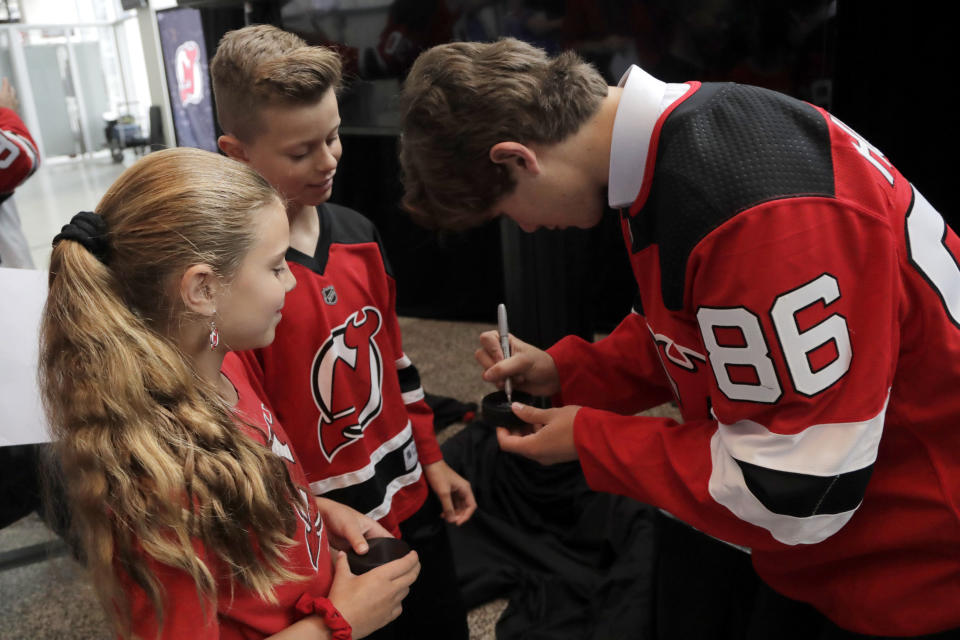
left=575, top=197, right=900, bottom=549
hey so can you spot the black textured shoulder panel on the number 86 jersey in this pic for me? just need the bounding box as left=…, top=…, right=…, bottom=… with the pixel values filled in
left=631, top=83, right=835, bottom=311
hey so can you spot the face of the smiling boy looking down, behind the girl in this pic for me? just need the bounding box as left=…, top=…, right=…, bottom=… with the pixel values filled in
left=228, top=89, right=343, bottom=205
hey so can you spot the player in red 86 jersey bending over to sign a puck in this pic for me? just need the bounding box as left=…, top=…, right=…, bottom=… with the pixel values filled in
left=401, top=40, right=960, bottom=638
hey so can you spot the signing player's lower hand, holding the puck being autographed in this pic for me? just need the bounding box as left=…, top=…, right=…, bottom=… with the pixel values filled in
left=497, top=402, right=580, bottom=465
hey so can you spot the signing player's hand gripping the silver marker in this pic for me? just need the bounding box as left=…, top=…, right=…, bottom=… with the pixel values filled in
left=473, top=331, right=560, bottom=396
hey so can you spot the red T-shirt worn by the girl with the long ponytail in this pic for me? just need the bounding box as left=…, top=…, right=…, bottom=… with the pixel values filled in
left=130, top=353, right=333, bottom=640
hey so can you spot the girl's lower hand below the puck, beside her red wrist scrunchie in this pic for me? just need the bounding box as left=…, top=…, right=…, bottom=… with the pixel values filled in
left=327, top=551, right=420, bottom=639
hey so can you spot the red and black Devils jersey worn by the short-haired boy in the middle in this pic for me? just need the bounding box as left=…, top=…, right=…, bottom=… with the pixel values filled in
left=243, top=203, right=442, bottom=536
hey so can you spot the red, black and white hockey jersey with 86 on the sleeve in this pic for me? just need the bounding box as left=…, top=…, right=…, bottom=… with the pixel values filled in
left=550, top=83, right=960, bottom=635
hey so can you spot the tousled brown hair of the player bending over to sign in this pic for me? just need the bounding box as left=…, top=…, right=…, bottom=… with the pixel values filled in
left=400, top=38, right=607, bottom=229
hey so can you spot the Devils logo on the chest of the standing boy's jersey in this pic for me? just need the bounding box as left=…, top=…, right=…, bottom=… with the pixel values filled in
left=311, top=307, right=383, bottom=461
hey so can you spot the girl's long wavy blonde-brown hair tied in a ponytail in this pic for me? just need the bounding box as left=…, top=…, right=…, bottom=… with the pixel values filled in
left=39, top=148, right=298, bottom=637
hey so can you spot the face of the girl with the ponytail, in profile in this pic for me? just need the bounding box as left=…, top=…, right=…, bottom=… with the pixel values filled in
left=216, top=201, right=297, bottom=351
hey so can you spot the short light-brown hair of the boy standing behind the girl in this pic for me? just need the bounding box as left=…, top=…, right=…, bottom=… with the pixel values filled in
left=210, top=24, right=342, bottom=142
